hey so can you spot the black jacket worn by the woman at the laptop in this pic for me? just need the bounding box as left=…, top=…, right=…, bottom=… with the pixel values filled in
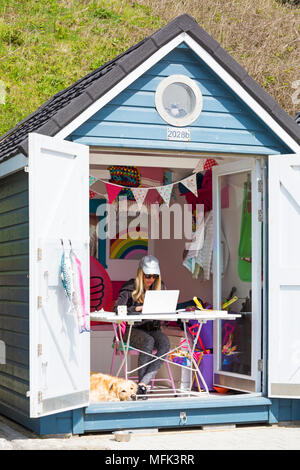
left=114, top=279, right=166, bottom=331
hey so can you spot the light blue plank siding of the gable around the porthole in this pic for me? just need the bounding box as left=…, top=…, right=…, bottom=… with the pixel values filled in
left=72, top=47, right=290, bottom=154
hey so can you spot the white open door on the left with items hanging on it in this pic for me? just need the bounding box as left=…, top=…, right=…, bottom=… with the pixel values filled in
left=28, top=134, right=90, bottom=417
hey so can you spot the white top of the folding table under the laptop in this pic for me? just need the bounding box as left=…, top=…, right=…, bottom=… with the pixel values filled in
left=90, top=310, right=241, bottom=323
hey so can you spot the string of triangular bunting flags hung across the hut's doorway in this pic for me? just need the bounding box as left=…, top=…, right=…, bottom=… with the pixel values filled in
left=89, top=158, right=217, bottom=209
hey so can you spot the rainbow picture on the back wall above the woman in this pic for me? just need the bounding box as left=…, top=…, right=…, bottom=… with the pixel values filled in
left=110, top=229, right=148, bottom=260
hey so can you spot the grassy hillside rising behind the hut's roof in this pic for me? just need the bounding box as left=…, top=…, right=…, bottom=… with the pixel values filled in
left=0, top=0, right=300, bottom=135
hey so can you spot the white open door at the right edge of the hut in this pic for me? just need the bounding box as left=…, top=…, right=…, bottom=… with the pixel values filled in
left=268, top=154, right=300, bottom=398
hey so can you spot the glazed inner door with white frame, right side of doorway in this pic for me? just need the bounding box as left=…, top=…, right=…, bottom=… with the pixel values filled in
left=213, top=158, right=262, bottom=392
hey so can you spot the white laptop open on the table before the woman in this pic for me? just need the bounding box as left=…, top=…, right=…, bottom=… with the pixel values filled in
left=142, top=290, right=179, bottom=314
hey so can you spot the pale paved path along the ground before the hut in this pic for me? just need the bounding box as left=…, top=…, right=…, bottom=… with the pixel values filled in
left=0, top=416, right=300, bottom=451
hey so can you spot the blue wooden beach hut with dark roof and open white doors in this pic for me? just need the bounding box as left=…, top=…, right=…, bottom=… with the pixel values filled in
left=0, top=15, right=300, bottom=434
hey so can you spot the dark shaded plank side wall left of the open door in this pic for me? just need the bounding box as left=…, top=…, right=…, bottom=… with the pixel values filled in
left=0, top=171, right=29, bottom=416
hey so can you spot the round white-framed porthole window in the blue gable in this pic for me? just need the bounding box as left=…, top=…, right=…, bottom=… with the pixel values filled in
left=155, top=75, right=202, bottom=127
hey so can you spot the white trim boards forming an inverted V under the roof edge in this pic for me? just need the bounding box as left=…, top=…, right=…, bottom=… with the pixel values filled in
left=56, top=33, right=300, bottom=153
